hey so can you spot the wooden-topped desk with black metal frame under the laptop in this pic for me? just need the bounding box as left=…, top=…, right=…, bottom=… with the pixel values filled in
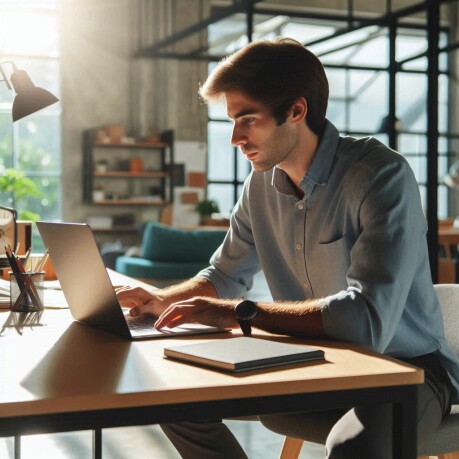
left=0, top=310, right=423, bottom=459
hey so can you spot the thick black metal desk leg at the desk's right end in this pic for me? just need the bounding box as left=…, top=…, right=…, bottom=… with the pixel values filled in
left=393, top=385, right=417, bottom=459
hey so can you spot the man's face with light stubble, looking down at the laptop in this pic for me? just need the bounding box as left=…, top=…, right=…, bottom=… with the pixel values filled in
left=225, top=91, right=298, bottom=172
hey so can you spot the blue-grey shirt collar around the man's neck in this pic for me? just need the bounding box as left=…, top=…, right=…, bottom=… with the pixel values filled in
left=272, top=120, right=339, bottom=196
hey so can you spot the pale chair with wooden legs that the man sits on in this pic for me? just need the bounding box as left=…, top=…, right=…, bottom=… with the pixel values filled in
left=280, top=284, right=459, bottom=459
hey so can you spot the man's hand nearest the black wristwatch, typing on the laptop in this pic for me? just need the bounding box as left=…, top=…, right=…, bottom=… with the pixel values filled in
left=155, top=296, right=240, bottom=328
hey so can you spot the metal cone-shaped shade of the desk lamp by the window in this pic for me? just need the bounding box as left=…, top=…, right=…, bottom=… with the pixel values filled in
left=11, top=70, right=59, bottom=121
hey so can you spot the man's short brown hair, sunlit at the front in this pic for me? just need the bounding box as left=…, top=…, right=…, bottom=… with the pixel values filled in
left=199, top=38, right=328, bottom=135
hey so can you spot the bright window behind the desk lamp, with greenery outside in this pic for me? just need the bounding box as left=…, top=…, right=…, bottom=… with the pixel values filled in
left=0, top=0, right=61, bottom=248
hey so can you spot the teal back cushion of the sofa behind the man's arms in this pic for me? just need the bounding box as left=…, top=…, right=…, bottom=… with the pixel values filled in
left=140, top=222, right=227, bottom=262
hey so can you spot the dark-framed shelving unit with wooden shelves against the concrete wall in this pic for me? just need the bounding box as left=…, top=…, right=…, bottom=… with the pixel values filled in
left=83, top=129, right=174, bottom=241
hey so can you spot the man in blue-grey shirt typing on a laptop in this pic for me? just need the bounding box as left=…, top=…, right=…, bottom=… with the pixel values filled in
left=119, top=39, right=459, bottom=459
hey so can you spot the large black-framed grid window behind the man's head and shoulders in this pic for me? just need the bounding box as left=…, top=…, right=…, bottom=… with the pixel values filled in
left=208, top=10, right=451, bottom=218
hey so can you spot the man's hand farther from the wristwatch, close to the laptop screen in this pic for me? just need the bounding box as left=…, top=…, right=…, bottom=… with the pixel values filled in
left=115, top=287, right=167, bottom=317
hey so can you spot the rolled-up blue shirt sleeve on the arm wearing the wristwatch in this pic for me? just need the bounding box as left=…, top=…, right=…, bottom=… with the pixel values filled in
left=321, top=157, right=429, bottom=352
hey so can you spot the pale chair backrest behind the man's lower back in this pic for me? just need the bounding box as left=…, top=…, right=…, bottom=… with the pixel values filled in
left=434, top=284, right=459, bottom=355
